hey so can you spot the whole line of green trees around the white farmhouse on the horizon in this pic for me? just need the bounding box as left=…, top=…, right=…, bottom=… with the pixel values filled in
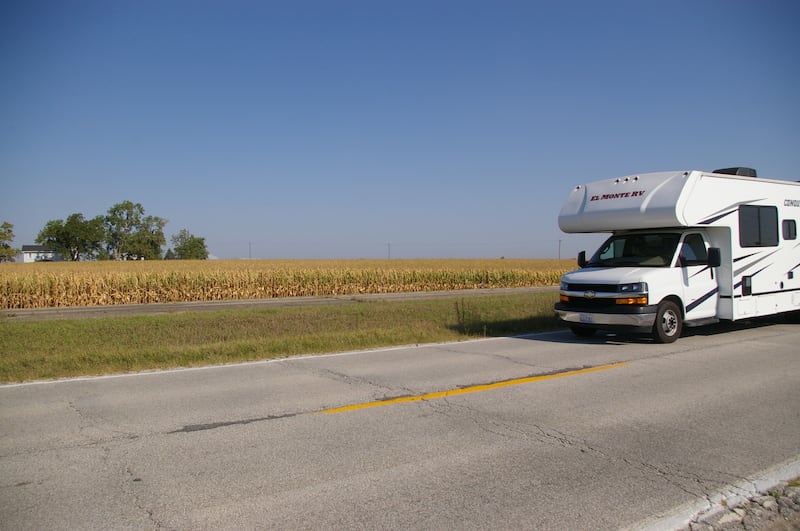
left=0, top=201, right=208, bottom=262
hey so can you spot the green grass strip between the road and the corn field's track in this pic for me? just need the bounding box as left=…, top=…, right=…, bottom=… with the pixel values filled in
left=0, top=292, right=558, bottom=383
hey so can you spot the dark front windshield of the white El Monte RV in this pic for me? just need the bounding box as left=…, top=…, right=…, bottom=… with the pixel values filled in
left=587, top=233, right=680, bottom=267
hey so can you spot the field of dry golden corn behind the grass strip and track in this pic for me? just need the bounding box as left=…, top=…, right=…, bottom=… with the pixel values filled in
left=0, top=259, right=572, bottom=310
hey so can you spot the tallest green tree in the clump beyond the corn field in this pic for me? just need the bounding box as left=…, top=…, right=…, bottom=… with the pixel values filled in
left=105, top=201, right=167, bottom=260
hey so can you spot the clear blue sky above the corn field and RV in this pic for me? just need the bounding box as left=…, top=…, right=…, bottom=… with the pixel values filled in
left=0, top=0, right=800, bottom=258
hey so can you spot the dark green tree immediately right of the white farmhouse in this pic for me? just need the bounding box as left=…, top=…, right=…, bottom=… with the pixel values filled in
left=36, top=213, right=105, bottom=262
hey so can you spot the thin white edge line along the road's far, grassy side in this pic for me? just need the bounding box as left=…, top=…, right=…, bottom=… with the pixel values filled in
left=0, top=330, right=564, bottom=390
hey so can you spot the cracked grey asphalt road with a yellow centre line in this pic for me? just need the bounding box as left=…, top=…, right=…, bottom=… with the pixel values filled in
left=0, top=318, right=800, bottom=529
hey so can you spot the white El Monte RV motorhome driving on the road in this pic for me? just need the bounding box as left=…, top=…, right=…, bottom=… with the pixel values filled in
left=555, top=168, right=800, bottom=343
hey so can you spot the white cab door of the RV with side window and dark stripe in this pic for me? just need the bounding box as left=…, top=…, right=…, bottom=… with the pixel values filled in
left=677, top=232, right=719, bottom=321
